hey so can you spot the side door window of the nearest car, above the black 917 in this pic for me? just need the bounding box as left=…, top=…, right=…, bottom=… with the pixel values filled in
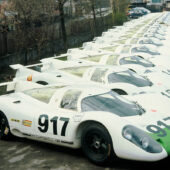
left=60, top=90, right=81, bottom=111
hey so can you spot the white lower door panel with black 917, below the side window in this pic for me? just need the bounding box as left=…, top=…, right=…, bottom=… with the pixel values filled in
left=35, top=109, right=75, bottom=143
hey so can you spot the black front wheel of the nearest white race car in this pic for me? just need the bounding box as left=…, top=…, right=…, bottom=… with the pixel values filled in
left=81, top=124, right=114, bottom=165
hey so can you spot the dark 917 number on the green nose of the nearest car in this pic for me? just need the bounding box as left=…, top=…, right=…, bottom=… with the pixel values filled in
left=146, top=117, right=170, bottom=137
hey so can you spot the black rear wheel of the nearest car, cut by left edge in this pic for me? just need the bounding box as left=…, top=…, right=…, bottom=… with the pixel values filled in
left=0, top=112, right=12, bottom=140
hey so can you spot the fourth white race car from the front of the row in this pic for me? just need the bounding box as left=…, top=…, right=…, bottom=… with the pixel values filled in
left=83, top=42, right=170, bottom=68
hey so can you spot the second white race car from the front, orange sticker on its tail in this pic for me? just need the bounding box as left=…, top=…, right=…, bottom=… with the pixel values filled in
left=9, top=61, right=170, bottom=113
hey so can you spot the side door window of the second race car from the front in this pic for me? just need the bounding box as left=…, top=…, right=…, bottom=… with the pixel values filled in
left=91, top=68, right=108, bottom=83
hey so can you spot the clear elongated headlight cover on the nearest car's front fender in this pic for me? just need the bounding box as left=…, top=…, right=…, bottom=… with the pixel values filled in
left=122, top=125, right=162, bottom=153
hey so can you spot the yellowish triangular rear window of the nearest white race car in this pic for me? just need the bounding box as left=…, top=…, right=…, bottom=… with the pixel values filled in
left=24, top=86, right=61, bottom=103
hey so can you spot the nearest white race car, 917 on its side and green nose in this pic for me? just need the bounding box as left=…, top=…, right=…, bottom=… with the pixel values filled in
left=0, top=81, right=170, bottom=164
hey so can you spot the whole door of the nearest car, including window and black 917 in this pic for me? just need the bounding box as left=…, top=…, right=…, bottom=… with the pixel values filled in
left=35, top=90, right=80, bottom=144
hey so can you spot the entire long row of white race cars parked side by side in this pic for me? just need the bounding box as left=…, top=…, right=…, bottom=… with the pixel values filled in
left=0, top=12, right=170, bottom=164
